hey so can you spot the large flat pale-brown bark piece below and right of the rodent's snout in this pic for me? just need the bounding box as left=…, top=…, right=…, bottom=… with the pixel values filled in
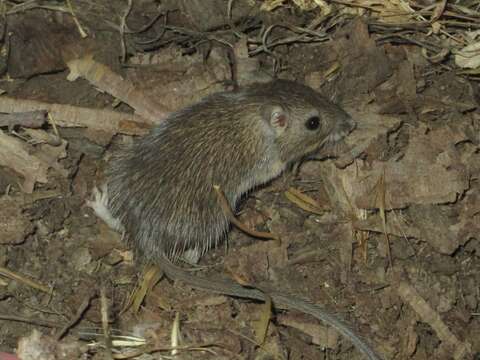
left=336, top=123, right=469, bottom=210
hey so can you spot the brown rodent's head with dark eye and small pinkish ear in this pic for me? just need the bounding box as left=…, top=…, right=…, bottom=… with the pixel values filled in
left=255, top=80, right=355, bottom=162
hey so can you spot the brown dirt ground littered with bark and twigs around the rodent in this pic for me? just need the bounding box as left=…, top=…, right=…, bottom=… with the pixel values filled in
left=0, top=0, right=480, bottom=360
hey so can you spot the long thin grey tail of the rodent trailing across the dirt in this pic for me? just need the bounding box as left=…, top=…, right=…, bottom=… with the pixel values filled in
left=159, top=256, right=381, bottom=360
